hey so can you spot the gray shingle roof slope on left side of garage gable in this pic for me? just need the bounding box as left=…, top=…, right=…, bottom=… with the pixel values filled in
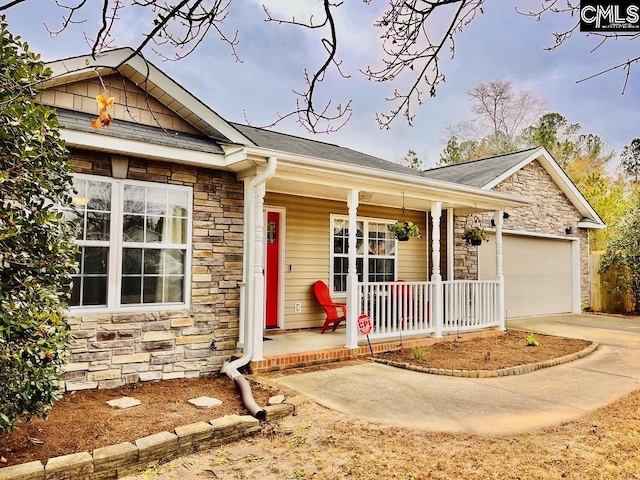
left=423, top=147, right=537, bottom=188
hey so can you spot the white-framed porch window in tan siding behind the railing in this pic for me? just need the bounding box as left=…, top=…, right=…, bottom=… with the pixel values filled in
left=329, top=215, right=398, bottom=296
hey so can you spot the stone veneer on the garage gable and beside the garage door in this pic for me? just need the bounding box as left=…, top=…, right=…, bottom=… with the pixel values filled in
left=454, top=160, right=590, bottom=306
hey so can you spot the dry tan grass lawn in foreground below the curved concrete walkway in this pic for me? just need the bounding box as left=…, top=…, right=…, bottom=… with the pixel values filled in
left=119, top=391, right=640, bottom=480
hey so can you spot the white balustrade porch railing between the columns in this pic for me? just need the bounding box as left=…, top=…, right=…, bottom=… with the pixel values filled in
left=358, top=280, right=499, bottom=340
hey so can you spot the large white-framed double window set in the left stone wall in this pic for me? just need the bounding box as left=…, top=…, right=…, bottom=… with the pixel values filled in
left=66, top=174, right=192, bottom=312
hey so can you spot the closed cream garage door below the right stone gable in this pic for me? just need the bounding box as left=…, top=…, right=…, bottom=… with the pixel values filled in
left=478, top=235, right=573, bottom=318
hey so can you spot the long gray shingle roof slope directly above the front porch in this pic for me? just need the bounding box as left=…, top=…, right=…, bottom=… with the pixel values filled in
left=232, top=123, right=421, bottom=176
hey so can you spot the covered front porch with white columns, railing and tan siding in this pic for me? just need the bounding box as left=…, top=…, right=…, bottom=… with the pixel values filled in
left=232, top=150, right=528, bottom=369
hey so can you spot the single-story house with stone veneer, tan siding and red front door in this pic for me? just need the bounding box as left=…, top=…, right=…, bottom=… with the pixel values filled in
left=39, top=48, right=603, bottom=390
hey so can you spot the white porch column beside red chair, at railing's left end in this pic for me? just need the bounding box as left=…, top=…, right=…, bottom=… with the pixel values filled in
left=345, top=190, right=359, bottom=348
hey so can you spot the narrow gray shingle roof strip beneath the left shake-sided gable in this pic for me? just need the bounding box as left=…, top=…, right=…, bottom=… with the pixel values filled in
left=56, top=108, right=224, bottom=154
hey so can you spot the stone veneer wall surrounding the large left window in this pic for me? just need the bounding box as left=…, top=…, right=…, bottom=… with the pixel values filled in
left=62, top=151, right=243, bottom=391
